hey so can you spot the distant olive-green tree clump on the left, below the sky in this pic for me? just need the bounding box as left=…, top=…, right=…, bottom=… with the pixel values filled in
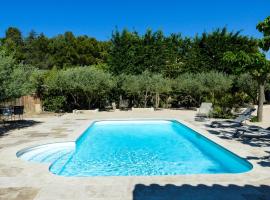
left=1, top=27, right=110, bottom=69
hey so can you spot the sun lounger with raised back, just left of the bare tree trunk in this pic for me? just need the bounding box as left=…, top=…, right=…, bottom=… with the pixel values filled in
left=210, top=108, right=256, bottom=128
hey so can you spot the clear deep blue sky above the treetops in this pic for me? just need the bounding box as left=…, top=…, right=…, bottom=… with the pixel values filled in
left=0, top=0, right=270, bottom=40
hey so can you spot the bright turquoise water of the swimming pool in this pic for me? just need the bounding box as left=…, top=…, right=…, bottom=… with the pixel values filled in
left=17, top=120, right=252, bottom=176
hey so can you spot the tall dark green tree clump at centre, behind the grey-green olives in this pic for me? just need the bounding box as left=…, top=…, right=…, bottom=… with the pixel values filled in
left=108, top=30, right=185, bottom=76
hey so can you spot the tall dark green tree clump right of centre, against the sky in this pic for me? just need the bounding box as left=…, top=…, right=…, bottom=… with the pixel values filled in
left=183, top=28, right=257, bottom=74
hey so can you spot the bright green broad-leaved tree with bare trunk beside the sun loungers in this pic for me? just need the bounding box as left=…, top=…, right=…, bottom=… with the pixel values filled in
left=223, top=51, right=270, bottom=122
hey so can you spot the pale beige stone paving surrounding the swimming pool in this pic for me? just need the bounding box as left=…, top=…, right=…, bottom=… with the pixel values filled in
left=0, top=109, right=270, bottom=200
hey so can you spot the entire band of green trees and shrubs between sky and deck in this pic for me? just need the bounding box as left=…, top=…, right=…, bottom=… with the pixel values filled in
left=0, top=24, right=270, bottom=117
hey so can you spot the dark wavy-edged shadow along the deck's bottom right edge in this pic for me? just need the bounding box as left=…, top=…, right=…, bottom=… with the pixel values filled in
left=133, top=184, right=270, bottom=200
